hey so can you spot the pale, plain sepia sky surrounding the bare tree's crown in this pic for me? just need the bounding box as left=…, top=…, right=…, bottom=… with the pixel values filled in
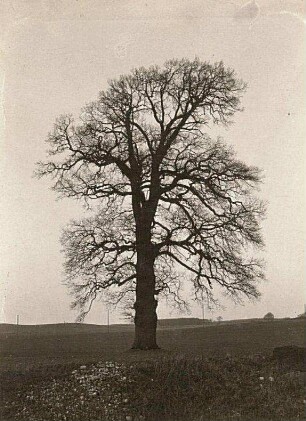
left=0, top=0, right=306, bottom=324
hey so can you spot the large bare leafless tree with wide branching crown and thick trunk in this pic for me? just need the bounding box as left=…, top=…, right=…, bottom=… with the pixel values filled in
left=38, top=59, right=264, bottom=349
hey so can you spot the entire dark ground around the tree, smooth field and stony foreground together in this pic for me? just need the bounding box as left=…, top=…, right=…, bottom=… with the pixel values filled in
left=0, top=319, right=305, bottom=421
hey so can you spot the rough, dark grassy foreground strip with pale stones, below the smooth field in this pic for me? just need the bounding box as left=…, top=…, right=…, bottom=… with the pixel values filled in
left=1, top=351, right=305, bottom=421
